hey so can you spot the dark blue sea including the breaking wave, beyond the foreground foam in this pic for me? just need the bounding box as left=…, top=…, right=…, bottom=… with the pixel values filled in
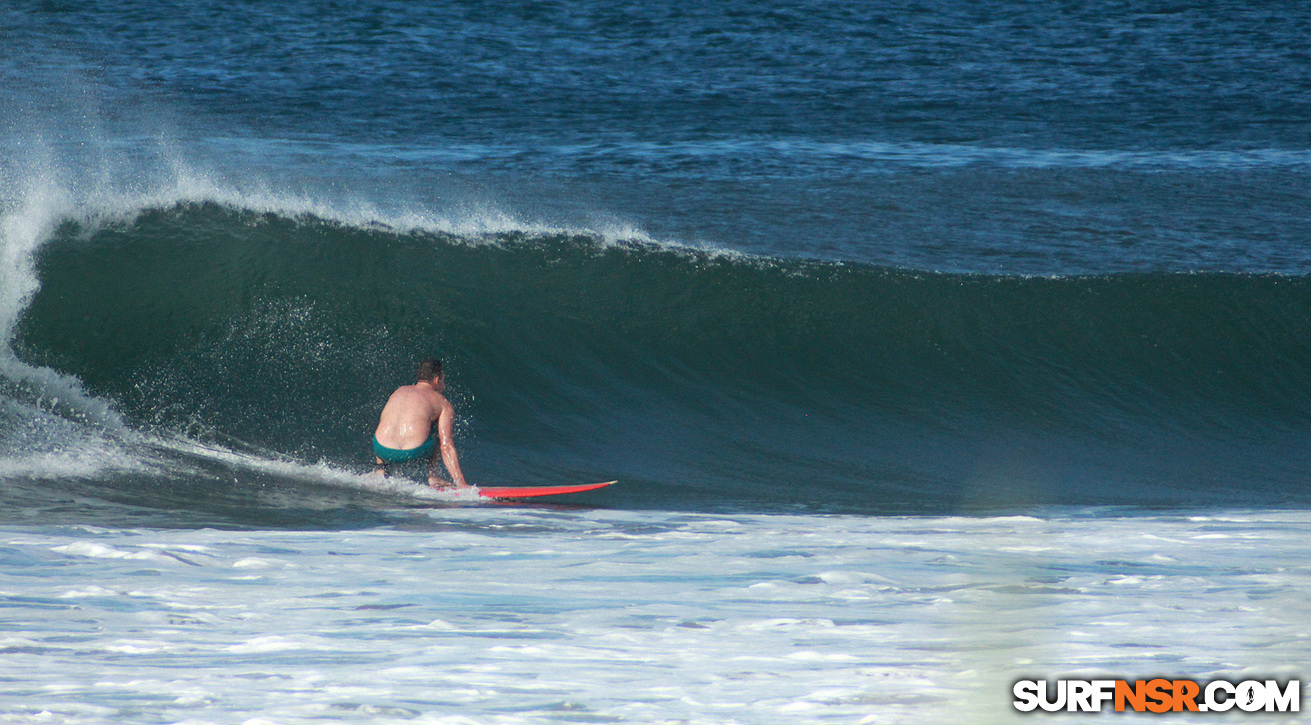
left=0, top=0, right=1311, bottom=526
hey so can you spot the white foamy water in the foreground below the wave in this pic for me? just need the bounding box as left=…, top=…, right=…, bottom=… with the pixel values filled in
left=0, top=507, right=1311, bottom=725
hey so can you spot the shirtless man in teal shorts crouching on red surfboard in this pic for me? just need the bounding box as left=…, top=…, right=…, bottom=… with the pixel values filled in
left=374, top=361, right=469, bottom=489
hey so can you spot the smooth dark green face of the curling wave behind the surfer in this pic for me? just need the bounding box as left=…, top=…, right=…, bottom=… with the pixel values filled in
left=5, top=203, right=1311, bottom=513
